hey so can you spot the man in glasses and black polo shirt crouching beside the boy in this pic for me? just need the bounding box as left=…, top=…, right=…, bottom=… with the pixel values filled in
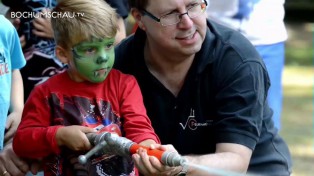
left=116, top=0, right=291, bottom=175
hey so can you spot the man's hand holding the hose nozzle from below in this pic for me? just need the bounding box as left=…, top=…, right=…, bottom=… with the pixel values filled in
left=132, top=144, right=182, bottom=175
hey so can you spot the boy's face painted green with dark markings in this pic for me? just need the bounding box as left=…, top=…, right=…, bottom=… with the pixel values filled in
left=72, top=38, right=115, bottom=83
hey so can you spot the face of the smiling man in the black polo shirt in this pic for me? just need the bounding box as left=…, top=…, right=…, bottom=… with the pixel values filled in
left=142, top=0, right=207, bottom=56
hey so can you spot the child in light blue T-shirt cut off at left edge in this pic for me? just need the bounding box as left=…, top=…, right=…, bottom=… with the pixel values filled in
left=0, top=15, right=29, bottom=176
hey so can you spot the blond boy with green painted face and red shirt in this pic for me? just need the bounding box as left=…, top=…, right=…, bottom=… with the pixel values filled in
left=13, top=0, right=159, bottom=175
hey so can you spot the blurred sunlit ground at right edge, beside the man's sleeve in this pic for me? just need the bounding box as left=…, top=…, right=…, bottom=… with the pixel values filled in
left=281, top=66, right=314, bottom=176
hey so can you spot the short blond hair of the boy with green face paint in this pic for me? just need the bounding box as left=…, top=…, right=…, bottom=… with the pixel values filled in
left=51, top=0, right=118, bottom=49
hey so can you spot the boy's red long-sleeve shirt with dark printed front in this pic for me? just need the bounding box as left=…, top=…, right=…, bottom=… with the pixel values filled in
left=13, top=69, right=159, bottom=175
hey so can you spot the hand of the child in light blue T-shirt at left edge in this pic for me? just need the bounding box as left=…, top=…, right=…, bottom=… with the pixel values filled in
left=4, top=112, right=21, bottom=145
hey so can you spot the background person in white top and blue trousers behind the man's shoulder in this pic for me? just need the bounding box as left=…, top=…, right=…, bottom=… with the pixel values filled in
left=207, top=0, right=288, bottom=129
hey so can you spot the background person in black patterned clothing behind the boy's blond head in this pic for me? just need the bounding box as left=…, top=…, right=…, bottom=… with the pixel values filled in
left=2, top=0, right=65, bottom=102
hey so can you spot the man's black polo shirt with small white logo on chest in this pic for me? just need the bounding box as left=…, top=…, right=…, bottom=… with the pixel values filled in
left=115, top=21, right=291, bottom=175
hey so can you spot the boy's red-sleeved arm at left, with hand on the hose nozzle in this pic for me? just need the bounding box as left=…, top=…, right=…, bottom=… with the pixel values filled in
left=13, top=85, right=94, bottom=159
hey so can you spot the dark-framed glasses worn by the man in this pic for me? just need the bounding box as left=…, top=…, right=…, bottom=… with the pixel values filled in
left=142, top=0, right=207, bottom=26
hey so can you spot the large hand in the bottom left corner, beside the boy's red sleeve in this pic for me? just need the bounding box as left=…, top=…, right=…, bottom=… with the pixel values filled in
left=0, top=143, right=29, bottom=176
